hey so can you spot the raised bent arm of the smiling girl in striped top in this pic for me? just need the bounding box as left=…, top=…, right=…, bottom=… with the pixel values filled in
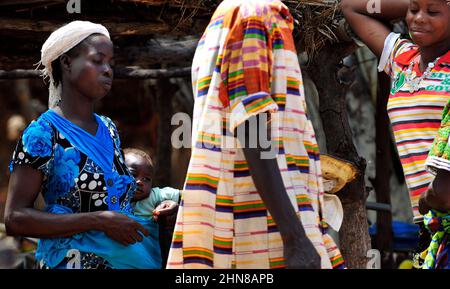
left=341, top=0, right=410, bottom=57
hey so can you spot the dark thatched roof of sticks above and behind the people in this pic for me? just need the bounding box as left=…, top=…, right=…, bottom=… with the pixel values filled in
left=0, top=0, right=342, bottom=69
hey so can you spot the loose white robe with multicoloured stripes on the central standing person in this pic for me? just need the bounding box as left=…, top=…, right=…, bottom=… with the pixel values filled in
left=167, top=0, right=344, bottom=269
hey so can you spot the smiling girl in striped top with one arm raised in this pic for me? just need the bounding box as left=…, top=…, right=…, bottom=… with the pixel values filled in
left=341, top=0, right=450, bottom=266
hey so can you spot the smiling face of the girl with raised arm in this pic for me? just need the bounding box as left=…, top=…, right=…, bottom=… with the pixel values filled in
left=406, top=0, right=450, bottom=47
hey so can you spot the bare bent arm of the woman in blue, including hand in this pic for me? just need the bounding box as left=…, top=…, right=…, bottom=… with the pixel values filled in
left=5, top=166, right=149, bottom=245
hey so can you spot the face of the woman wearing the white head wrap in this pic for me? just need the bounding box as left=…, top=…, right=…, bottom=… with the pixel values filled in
left=69, top=34, right=113, bottom=100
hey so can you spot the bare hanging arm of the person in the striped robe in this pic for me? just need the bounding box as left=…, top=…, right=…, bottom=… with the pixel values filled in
left=238, top=113, right=320, bottom=268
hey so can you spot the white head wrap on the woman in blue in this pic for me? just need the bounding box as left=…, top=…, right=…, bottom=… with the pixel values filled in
left=40, top=21, right=110, bottom=108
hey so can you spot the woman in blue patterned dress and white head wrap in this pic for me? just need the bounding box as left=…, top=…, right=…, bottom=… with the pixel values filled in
left=5, top=21, right=161, bottom=268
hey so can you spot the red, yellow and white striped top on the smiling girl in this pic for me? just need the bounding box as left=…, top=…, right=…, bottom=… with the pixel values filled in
left=380, top=34, right=450, bottom=222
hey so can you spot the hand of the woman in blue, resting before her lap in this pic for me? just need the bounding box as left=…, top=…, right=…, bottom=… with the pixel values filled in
left=97, top=211, right=150, bottom=246
